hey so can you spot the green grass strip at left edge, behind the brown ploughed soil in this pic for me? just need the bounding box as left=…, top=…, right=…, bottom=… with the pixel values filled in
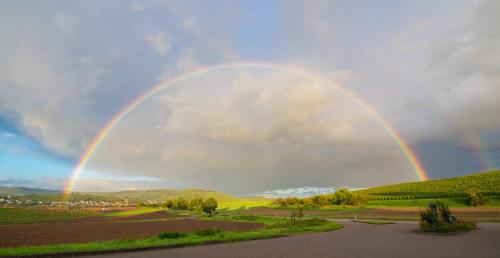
left=0, top=208, right=99, bottom=224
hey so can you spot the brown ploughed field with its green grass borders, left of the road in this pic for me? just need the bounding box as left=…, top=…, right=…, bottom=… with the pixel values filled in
left=0, top=208, right=341, bottom=256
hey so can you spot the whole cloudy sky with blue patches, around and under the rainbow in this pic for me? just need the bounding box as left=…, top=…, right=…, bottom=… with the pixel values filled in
left=0, top=0, right=500, bottom=194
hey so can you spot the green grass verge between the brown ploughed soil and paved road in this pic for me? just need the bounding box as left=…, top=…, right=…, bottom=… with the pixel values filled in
left=0, top=215, right=343, bottom=257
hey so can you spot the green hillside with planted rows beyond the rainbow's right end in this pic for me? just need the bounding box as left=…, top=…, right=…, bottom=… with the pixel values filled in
left=356, top=170, right=500, bottom=196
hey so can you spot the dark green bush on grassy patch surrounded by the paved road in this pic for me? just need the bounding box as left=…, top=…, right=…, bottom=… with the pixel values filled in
left=420, top=202, right=476, bottom=233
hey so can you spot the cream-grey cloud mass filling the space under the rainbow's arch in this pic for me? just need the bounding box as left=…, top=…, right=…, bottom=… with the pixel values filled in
left=89, top=70, right=413, bottom=193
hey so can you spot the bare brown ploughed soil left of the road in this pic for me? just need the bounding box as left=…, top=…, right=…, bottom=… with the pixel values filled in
left=0, top=211, right=263, bottom=248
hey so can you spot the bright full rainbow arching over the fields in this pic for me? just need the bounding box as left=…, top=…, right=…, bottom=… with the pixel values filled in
left=64, top=62, right=428, bottom=194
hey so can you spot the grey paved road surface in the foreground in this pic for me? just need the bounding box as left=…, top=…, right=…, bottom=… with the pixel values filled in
left=82, top=221, right=500, bottom=258
